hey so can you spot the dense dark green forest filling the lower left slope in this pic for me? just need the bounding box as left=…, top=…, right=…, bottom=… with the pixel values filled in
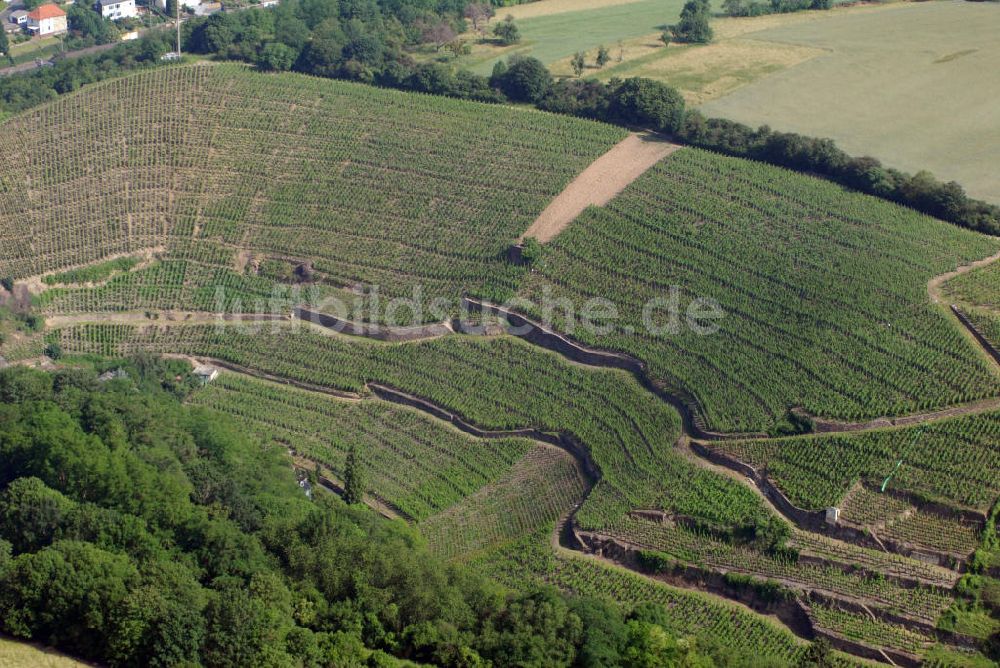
left=0, top=358, right=752, bottom=668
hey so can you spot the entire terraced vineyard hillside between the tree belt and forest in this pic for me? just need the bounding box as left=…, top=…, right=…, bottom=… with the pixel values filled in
left=7, top=65, right=1000, bottom=665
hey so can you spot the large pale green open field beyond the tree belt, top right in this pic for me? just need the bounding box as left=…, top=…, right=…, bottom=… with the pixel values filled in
left=702, top=0, right=1000, bottom=202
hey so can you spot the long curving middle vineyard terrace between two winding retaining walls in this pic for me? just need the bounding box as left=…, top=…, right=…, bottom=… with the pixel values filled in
left=50, top=324, right=776, bottom=528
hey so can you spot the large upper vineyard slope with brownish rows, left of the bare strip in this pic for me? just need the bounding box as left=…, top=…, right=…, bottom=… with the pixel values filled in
left=0, top=65, right=625, bottom=319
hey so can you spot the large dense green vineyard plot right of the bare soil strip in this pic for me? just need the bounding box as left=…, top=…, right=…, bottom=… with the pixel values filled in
left=521, top=149, right=998, bottom=431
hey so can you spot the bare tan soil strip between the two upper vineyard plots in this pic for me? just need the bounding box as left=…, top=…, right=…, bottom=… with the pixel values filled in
left=521, top=134, right=680, bottom=243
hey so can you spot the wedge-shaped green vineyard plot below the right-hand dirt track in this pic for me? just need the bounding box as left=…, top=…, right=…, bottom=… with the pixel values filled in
left=714, top=412, right=1000, bottom=511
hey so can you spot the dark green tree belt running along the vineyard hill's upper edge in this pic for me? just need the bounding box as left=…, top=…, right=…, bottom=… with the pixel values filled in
left=0, top=0, right=1000, bottom=234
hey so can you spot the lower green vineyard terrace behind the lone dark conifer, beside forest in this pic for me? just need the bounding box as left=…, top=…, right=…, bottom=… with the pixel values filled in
left=192, top=374, right=533, bottom=520
